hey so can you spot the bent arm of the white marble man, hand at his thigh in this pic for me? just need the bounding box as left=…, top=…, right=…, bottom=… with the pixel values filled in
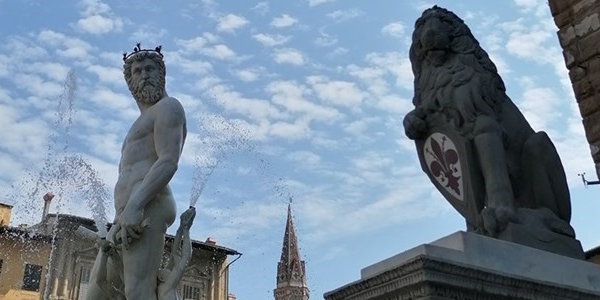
left=118, top=97, right=186, bottom=248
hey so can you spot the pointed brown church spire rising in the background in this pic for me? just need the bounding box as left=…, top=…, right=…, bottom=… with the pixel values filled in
left=274, top=198, right=308, bottom=300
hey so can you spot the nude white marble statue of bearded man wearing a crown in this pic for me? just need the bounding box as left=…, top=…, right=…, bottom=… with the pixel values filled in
left=88, top=44, right=186, bottom=300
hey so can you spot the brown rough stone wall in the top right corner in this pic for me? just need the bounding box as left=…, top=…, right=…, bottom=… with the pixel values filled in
left=548, top=0, right=600, bottom=177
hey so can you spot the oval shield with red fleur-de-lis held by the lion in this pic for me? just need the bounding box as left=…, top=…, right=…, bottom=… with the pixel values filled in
left=415, top=126, right=485, bottom=229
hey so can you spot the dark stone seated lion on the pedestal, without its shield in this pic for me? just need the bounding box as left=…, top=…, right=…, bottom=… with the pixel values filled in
left=403, top=6, right=575, bottom=238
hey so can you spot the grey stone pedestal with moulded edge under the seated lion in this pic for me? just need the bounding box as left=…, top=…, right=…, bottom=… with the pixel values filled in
left=324, top=231, right=600, bottom=300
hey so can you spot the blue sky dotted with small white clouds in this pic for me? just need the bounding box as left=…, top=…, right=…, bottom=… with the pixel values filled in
left=0, top=0, right=600, bottom=300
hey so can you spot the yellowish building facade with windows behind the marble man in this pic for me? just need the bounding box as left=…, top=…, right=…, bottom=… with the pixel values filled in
left=0, top=202, right=240, bottom=300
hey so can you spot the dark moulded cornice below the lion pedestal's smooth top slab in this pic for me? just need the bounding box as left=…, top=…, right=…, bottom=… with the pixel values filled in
left=324, top=255, right=600, bottom=300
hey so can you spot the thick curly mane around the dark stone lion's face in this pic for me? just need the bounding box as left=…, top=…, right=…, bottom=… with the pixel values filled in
left=409, top=6, right=510, bottom=131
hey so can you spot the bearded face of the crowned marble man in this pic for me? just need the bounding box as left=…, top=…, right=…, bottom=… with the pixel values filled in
left=128, top=59, right=165, bottom=104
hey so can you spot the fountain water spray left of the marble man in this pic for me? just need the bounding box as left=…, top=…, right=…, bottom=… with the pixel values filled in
left=3, top=70, right=109, bottom=299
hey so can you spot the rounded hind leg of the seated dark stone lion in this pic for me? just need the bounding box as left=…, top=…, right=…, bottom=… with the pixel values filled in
left=521, top=131, right=571, bottom=223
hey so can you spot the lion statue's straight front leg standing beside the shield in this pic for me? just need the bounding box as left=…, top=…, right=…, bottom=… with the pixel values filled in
left=473, top=116, right=515, bottom=236
